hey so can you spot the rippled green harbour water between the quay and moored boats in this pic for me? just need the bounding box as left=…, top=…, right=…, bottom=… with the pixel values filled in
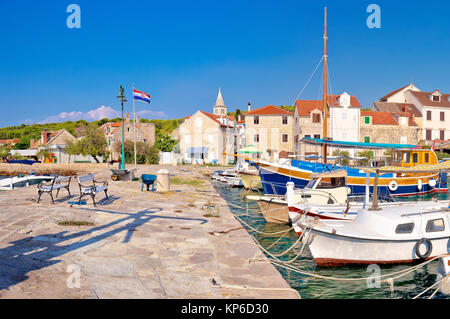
left=214, top=182, right=450, bottom=299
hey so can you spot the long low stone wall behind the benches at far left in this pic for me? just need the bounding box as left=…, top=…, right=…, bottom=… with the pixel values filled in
left=0, top=163, right=108, bottom=176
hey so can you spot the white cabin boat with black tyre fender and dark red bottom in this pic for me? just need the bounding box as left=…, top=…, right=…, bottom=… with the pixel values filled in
left=297, top=202, right=450, bottom=266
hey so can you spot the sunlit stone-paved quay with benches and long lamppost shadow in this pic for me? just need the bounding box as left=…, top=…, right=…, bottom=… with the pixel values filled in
left=0, top=166, right=297, bottom=298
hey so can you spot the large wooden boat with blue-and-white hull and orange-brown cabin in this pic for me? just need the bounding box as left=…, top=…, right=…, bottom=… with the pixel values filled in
left=250, top=138, right=450, bottom=196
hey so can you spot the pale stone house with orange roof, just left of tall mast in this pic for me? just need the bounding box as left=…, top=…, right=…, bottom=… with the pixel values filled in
left=245, top=105, right=294, bottom=161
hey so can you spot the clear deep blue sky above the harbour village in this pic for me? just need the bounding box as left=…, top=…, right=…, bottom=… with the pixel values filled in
left=0, top=0, right=450, bottom=126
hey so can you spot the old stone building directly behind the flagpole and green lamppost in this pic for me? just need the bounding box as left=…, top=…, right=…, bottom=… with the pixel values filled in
left=99, top=113, right=156, bottom=160
